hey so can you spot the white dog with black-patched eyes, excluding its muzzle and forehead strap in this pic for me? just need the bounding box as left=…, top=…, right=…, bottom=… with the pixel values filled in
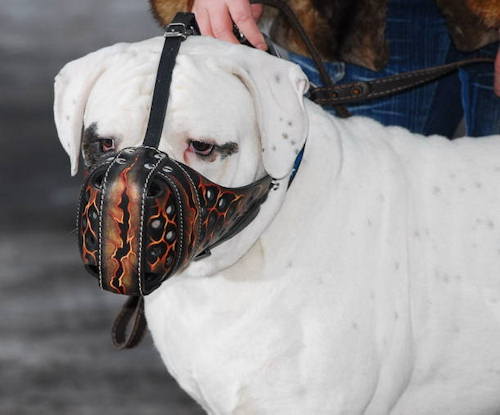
left=55, top=37, right=500, bottom=415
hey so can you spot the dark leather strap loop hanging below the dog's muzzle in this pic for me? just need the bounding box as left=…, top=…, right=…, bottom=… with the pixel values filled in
left=111, top=297, right=147, bottom=350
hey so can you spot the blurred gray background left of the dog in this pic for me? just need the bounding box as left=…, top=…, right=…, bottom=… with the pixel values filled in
left=0, top=0, right=202, bottom=415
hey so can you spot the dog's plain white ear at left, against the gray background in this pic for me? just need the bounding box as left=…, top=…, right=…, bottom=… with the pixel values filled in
left=54, top=44, right=126, bottom=176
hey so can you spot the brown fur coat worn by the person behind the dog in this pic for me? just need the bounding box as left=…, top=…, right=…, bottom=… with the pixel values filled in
left=149, top=0, right=500, bottom=70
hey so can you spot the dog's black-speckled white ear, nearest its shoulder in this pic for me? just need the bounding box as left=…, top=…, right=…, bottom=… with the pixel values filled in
left=227, top=46, right=309, bottom=179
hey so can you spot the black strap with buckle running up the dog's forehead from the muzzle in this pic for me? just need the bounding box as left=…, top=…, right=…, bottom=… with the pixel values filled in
left=143, top=13, right=200, bottom=148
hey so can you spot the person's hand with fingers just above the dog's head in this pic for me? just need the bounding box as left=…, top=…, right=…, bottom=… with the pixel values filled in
left=192, top=0, right=267, bottom=50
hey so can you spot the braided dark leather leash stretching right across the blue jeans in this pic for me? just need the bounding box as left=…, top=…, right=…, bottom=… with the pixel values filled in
left=309, top=58, right=493, bottom=105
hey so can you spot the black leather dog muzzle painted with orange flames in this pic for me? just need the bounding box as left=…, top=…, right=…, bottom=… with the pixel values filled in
left=78, top=146, right=272, bottom=295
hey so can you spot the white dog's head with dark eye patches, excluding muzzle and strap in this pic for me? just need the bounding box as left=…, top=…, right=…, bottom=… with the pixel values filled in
left=54, top=37, right=308, bottom=290
